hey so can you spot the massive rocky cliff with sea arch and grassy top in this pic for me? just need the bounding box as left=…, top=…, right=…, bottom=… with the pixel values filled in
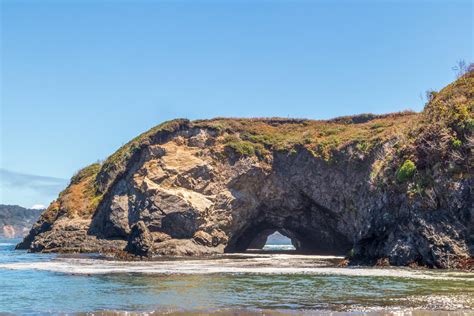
left=18, top=73, right=474, bottom=267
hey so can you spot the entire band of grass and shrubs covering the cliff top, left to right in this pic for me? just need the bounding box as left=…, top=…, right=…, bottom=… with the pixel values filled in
left=43, top=71, right=474, bottom=216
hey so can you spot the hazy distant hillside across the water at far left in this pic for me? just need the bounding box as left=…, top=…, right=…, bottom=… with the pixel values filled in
left=0, top=204, right=43, bottom=238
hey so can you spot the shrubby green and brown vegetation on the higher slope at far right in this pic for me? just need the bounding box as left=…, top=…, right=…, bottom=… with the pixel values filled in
left=374, top=71, right=474, bottom=201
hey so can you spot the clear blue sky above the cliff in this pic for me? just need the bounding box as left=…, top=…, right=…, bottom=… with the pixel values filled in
left=0, top=0, right=474, bottom=206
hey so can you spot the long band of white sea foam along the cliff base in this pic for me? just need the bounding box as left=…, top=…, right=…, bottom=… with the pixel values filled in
left=0, top=254, right=474, bottom=282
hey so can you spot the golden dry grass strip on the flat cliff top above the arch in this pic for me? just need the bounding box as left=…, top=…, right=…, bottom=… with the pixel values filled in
left=193, top=112, right=420, bottom=159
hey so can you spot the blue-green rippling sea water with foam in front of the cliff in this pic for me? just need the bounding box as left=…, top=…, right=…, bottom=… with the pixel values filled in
left=0, top=239, right=474, bottom=315
